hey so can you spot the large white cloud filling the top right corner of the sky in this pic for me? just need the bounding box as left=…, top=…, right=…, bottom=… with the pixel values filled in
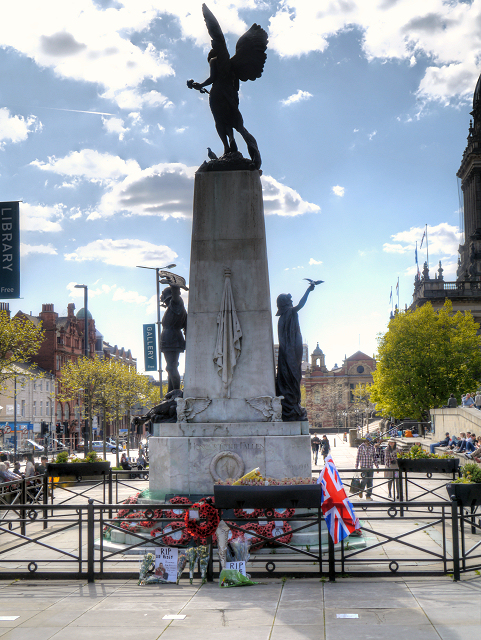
left=269, top=0, right=481, bottom=101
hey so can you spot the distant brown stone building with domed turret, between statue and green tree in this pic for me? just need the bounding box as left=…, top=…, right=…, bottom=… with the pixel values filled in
left=302, top=344, right=376, bottom=431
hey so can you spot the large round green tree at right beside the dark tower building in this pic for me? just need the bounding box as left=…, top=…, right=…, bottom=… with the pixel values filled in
left=371, top=300, right=481, bottom=421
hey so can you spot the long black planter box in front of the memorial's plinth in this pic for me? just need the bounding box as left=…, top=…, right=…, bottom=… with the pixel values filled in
left=214, top=484, right=321, bottom=509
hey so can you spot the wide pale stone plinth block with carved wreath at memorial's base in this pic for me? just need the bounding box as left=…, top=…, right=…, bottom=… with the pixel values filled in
left=149, top=422, right=311, bottom=499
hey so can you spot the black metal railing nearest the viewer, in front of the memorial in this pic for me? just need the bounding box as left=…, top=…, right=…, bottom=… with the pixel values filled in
left=0, top=498, right=481, bottom=581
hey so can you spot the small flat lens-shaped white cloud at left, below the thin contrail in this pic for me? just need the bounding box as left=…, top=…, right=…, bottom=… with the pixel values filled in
left=30, top=149, right=140, bottom=182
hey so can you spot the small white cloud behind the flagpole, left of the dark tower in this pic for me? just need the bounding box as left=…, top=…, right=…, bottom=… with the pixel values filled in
left=383, top=222, right=462, bottom=264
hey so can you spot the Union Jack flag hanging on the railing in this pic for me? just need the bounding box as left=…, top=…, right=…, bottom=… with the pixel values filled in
left=317, top=454, right=361, bottom=544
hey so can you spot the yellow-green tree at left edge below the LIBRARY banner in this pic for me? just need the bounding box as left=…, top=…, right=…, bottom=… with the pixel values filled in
left=0, top=311, right=44, bottom=389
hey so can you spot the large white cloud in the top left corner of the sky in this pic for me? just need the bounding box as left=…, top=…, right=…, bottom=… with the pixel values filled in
left=0, top=0, right=173, bottom=109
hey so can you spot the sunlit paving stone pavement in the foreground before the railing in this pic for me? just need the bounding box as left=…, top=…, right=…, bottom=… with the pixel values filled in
left=0, top=576, right=481, bottom=640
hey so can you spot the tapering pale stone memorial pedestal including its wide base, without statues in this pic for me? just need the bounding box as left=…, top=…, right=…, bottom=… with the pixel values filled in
left=149, top=171, right=311, bottom=498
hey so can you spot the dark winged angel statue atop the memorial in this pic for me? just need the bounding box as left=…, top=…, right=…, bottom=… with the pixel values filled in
left=187, top=4, right=267, bottom=169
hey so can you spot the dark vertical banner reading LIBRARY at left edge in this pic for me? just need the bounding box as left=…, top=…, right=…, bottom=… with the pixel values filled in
left=0, top=202, right=20, bottom=300
